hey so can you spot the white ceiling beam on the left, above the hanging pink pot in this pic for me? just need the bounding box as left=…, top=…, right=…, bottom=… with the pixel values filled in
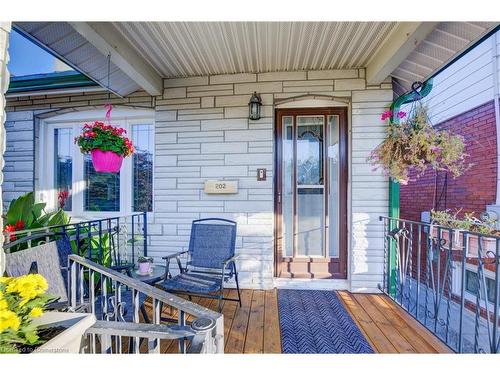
left=69, top=22, right=163, bottom=96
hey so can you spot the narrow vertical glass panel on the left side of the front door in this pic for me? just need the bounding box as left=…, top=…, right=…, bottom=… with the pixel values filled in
left=281, top=116, right=294, bottom=257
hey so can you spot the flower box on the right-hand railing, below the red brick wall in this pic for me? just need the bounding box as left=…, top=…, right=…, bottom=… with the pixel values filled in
left=431, top=210, right=500, bottom=257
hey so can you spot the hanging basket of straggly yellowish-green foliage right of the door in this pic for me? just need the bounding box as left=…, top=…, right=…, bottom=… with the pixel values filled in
left=368, top=106, right=470, bottom=185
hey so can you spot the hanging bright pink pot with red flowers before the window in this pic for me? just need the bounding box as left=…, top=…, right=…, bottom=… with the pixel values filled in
left=75, top=109, right=134, bottom=173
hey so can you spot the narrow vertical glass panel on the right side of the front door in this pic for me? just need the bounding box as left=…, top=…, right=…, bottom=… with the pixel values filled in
left=327, top=116, right=340, bottom=258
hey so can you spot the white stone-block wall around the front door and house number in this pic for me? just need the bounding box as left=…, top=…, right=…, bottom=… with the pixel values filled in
left=150, top=69, right=392, bottom=291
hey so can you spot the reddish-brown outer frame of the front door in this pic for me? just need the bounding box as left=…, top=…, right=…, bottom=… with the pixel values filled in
left=273, top=107, right=349, bottom=279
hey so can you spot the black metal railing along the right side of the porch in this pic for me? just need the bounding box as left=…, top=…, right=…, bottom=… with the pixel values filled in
left=380, top=217, right=500, bottom=353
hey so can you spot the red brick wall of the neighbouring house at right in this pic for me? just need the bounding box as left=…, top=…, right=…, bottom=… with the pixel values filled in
left=400, top=101, right=497, bottom=220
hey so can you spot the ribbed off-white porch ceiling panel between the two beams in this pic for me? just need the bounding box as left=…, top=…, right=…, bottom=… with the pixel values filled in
left=114, top=22, right=397, bottom=78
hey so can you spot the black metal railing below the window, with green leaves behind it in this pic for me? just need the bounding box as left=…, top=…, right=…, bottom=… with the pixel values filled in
left=3, top=212, right=148, bottom=267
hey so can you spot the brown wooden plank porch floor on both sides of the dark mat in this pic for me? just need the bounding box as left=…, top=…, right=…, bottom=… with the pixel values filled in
left=146, top=289, right=450, bottom=353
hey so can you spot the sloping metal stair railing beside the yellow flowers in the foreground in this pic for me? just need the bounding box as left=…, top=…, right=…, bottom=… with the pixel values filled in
left=69, top=255, right=224, bottom=353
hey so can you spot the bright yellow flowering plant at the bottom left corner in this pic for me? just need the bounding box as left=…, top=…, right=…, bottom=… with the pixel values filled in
left=0, top=274, right=54, bottom=353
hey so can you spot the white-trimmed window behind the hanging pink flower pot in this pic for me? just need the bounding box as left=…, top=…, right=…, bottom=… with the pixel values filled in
left=39, top=111, right=154, bottom=217
